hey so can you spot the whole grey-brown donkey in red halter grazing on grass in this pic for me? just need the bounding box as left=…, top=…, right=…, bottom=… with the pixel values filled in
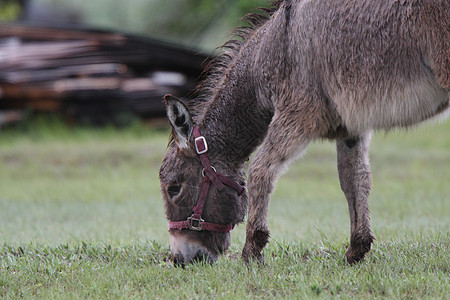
left=159, top=0, right=450, bottom=264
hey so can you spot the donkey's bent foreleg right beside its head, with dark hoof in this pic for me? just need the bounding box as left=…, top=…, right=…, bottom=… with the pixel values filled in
left=242, top=118, right=310, bottom=262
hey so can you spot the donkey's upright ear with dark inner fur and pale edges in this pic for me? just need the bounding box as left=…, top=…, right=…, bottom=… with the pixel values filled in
left=164, top=95, right=194, bottom=149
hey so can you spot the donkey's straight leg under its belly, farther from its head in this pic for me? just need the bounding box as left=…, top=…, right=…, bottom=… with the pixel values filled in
left=336, top=133, right=374, bottom=264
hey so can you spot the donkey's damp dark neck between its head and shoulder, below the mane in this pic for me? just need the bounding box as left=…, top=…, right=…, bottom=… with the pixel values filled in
left=195, top=9, right=283, bottom=166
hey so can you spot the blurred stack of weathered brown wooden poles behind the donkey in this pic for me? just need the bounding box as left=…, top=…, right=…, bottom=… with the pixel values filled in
left=0, top=24, right=206, bottom=126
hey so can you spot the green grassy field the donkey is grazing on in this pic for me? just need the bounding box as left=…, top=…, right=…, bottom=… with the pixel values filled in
left=0, top=117, right=450, bottom=299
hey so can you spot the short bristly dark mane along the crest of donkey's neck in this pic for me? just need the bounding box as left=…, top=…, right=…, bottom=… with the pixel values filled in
left=189, top=0, right=285, bottom=118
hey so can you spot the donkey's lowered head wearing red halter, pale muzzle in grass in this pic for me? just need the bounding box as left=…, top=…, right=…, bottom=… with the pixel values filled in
left=159, top=95, right=247, bottom=264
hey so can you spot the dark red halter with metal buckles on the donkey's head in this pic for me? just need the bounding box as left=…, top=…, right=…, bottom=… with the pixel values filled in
left=169, top=126, right=245, bottom=232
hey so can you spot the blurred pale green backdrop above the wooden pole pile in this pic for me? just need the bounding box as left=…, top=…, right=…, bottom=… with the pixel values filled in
left=37, top=0, right=270, bottom=49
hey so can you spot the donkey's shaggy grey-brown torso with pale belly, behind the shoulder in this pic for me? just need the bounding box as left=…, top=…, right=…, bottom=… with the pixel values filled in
left=278, top=0, right=450, bottom=133
